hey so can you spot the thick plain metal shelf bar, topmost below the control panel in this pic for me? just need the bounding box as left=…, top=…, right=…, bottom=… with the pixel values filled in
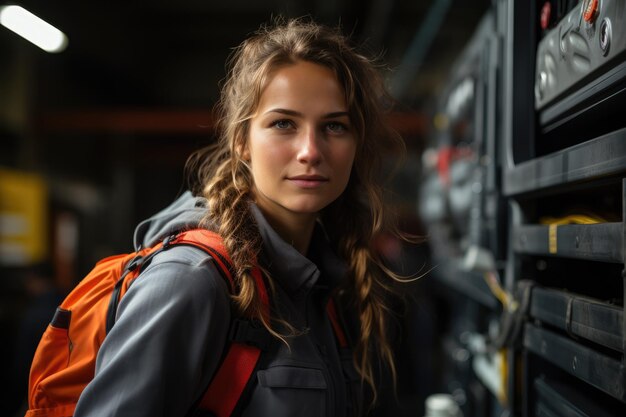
left=503, top=128, right=626, bottom=196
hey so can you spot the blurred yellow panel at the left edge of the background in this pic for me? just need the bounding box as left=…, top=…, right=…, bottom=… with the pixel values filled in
left=0, top=168, right=48, bottom=266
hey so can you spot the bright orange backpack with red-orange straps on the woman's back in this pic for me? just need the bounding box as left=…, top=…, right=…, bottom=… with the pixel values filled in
left=26, top=229, right=269, bottom=417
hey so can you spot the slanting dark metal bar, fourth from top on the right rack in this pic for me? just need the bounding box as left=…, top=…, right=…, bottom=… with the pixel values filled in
left=524, top=324, right=626, bottom=402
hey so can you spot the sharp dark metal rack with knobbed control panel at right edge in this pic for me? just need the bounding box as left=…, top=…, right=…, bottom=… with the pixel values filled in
left=499, top=0, right=626, bottom=417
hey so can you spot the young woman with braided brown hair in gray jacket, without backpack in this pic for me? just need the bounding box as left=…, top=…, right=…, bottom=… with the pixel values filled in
left=75, top=20, right=410, bottom=417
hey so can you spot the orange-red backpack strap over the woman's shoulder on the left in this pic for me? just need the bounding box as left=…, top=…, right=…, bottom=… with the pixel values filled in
left=172, top=229, right=271, bottom=417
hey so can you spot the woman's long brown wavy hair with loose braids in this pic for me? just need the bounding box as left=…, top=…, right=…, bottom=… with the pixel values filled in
left=187, top=18, right=404, bottom=402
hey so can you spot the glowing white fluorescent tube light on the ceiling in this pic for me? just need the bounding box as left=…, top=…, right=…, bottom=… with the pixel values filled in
left=0, top=6, right=67, bottom=52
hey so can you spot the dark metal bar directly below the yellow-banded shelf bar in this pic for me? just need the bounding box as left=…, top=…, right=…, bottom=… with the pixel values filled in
left=530, top=287, right=624, bottom=352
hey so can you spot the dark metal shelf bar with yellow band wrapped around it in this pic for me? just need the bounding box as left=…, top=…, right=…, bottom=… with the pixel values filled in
left=513, top=223, right=626, bottom=263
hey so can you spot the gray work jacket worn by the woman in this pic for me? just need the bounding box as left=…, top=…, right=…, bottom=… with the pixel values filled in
left=75, top=194, right=362, bottom=417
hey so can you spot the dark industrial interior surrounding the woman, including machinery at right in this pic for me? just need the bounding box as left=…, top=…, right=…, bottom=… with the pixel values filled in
left=6, top=0, right=626, bottom=417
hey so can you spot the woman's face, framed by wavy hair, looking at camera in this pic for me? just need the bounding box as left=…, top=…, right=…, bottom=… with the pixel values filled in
left=244, top=61, right=357, bottom=224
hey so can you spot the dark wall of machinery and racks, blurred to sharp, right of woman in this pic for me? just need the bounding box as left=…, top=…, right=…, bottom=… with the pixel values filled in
left=419, top=1, right=626, bottom=416
